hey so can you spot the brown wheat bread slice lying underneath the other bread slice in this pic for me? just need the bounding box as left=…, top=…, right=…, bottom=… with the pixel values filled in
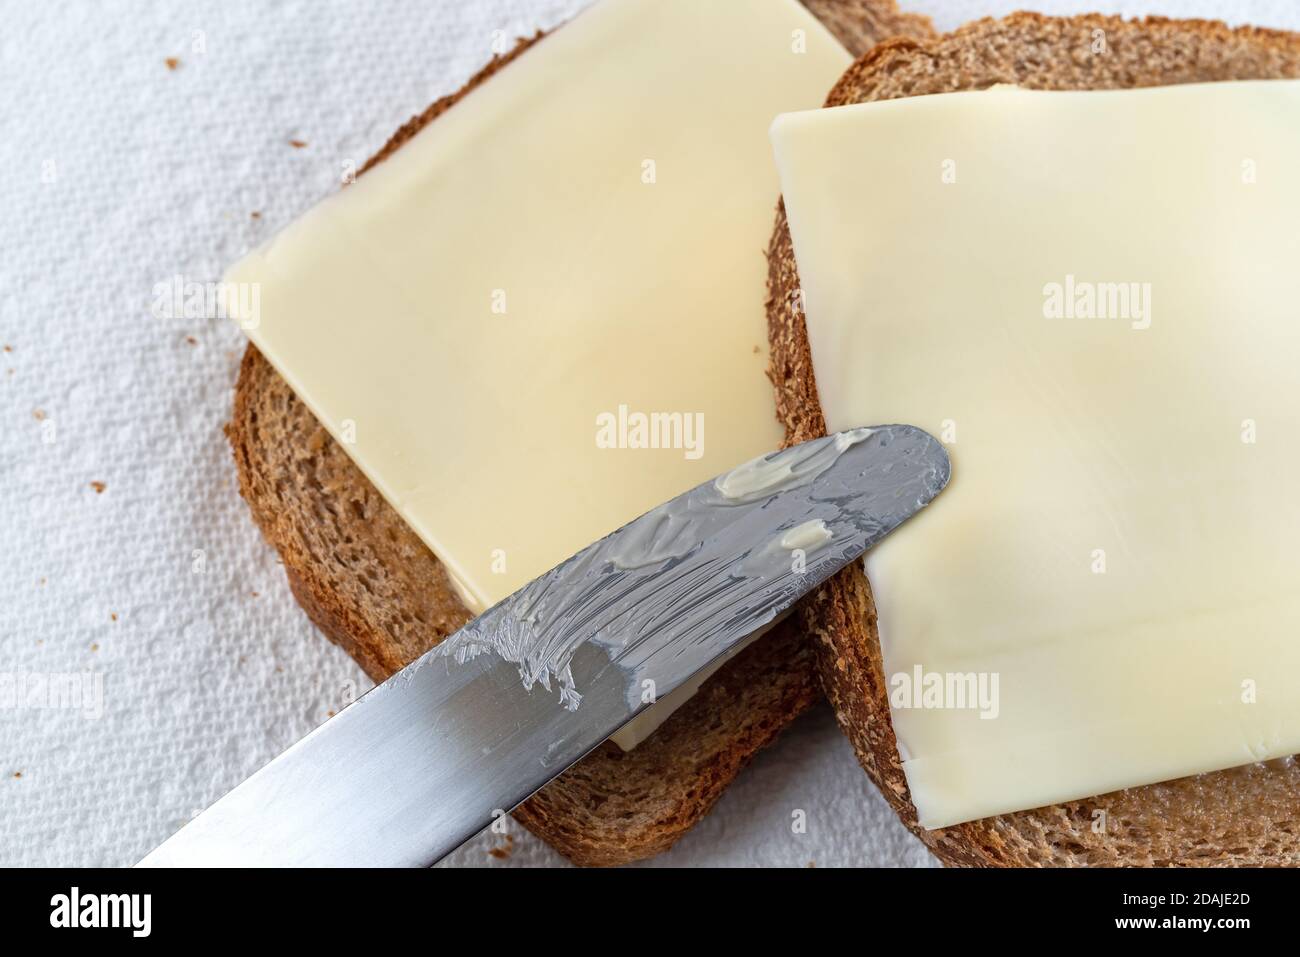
left=226, top=0, right=931, bottom=865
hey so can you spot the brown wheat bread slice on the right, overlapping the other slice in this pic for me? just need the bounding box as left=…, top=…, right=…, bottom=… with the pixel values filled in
left=768, top=13, right=1300, bottom=866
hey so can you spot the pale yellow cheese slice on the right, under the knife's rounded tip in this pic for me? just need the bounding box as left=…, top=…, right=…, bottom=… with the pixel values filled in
left=772, top=81, right=1300, bottom=827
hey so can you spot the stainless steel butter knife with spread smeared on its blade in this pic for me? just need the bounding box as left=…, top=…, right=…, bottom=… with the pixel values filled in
left=140, top=425, right=949, bottom=867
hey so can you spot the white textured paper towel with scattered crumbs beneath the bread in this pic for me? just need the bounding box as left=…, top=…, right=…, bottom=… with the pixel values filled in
left=0, top=0, right=1300, bottom=866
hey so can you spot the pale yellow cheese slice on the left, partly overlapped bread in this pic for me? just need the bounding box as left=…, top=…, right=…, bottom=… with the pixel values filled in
left=226, top=0, right=850, bottom=744
